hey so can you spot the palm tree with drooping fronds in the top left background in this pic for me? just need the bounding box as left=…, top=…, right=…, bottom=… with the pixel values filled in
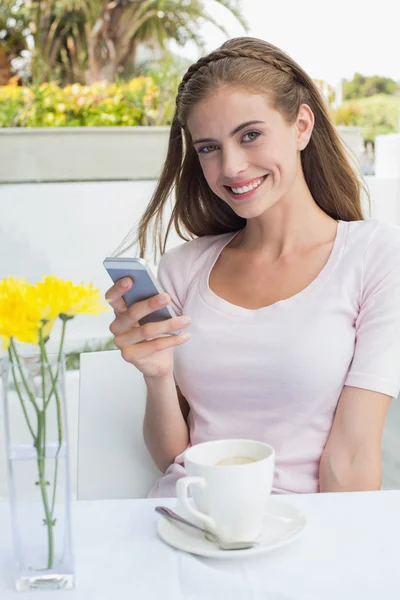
left=3, top=0, right=247, bottom=83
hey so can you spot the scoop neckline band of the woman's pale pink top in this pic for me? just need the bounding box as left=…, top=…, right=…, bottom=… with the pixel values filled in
left=199, top=220, right=349, bottom=319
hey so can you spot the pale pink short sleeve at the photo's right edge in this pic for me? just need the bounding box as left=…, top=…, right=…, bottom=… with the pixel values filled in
left=345, top=223, right=400, bottom=397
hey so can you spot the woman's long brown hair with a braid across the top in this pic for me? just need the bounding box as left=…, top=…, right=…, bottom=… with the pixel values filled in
left=122, top=37, right=363, bottom=256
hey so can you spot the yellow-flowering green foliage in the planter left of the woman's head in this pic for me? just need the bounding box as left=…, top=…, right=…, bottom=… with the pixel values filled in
left=0, top=72, right=180, bottom=127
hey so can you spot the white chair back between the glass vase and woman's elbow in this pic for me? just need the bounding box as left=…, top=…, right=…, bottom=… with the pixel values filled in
left=77, top=351, right=161, bottom=500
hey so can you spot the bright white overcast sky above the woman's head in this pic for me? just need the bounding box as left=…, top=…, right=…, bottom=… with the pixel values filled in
left=177, top=0, right=400, bottom=85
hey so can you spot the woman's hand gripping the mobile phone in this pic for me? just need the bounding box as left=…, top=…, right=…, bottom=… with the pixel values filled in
left=106, top=277, right=190, bottom=377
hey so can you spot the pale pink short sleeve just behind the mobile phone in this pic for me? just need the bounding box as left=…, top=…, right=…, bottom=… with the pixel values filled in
left=157, top=243, right=191, bottom=317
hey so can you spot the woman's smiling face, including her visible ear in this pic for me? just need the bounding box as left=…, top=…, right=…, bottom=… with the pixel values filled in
left=187, top=87, right=314, bottom=219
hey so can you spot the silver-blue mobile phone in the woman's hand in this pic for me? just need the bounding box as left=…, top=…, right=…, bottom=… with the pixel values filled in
left=103, top=256, right=180, bottom=334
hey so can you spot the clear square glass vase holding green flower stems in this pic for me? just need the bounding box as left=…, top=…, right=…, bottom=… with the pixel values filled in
left=1, top=352, right=74, bottom=591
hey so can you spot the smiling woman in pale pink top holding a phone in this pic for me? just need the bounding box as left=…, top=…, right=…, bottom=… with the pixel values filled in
left=107, top=38, right=400, bottom=497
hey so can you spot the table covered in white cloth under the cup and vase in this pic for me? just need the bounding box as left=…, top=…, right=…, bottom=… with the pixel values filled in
left=0, top=490, right=400, bottom=600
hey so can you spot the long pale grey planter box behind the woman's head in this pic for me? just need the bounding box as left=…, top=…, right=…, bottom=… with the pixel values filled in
left=0, top=127, right=362, bottom=183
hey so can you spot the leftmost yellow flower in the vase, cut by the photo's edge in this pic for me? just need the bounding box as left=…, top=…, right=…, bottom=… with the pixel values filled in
left=0, top=277, right=42, bottom=350
